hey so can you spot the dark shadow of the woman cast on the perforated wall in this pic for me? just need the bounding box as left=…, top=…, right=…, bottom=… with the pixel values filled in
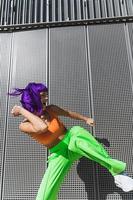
left=77, top=138, right=133, bottom=200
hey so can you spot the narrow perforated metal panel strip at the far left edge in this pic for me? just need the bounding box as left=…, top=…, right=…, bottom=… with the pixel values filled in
left=0, top=34, right=12, bottom=199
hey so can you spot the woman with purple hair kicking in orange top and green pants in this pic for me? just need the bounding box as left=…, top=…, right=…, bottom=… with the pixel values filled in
left=9, top=83, right=133, bottom=200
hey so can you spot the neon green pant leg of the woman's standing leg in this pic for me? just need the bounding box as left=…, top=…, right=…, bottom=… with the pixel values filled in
left=36, top=153, right=72, bottom=200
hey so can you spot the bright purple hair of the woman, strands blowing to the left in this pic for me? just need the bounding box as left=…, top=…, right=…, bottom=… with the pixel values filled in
left=8, top=82, right=48, bottom=115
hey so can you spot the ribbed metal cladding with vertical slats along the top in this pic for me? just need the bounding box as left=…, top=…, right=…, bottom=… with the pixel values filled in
left=0, top=0, right=133, bottom=25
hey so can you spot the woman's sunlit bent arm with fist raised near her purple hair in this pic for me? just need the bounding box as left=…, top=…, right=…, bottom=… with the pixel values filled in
left=11, top=106, right=48, bottom=133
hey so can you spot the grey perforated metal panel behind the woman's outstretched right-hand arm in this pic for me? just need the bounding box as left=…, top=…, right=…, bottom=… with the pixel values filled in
left=49, top=27, right=95, bottom=199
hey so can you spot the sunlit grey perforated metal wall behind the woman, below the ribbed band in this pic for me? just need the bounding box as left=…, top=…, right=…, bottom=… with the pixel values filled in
left=0, top=24, right=133, bottom=200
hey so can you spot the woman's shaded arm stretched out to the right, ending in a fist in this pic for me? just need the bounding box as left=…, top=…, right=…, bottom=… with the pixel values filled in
left=48, top=104, right=94, bottom=125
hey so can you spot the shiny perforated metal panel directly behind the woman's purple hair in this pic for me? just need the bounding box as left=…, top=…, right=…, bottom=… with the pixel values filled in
left=3, top=30, right=47, bottom=200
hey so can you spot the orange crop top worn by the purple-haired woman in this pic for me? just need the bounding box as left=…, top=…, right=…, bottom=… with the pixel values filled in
left=30, top=109, right=66, bottom=146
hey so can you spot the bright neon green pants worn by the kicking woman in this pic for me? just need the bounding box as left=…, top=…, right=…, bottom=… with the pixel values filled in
left=36, top=126, right=126, bottom=200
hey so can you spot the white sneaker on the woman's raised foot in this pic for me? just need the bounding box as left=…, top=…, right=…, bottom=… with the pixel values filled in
left=114, top=175, right=133, bottom=192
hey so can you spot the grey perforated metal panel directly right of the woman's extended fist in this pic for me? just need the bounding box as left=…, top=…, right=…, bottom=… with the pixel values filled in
left=88, top=24, right=133, bottom=200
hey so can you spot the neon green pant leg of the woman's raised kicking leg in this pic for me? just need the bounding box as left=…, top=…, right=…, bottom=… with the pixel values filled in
left=68, top=126, right=126, bottom=176
